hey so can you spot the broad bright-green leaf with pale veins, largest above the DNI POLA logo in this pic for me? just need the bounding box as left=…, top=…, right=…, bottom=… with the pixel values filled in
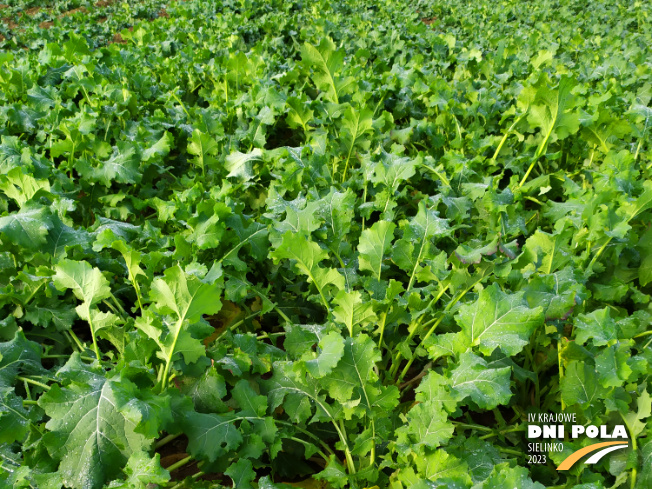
left=456, top=283, right=544, bottom=356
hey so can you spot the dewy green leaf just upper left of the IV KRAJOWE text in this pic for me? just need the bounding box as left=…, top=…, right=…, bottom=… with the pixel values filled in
left=450, top=353, right=512, bottom=409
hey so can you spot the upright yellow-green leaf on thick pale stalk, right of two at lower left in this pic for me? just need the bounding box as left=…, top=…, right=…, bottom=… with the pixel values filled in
left=136, top=265, right=223, bottom=389
